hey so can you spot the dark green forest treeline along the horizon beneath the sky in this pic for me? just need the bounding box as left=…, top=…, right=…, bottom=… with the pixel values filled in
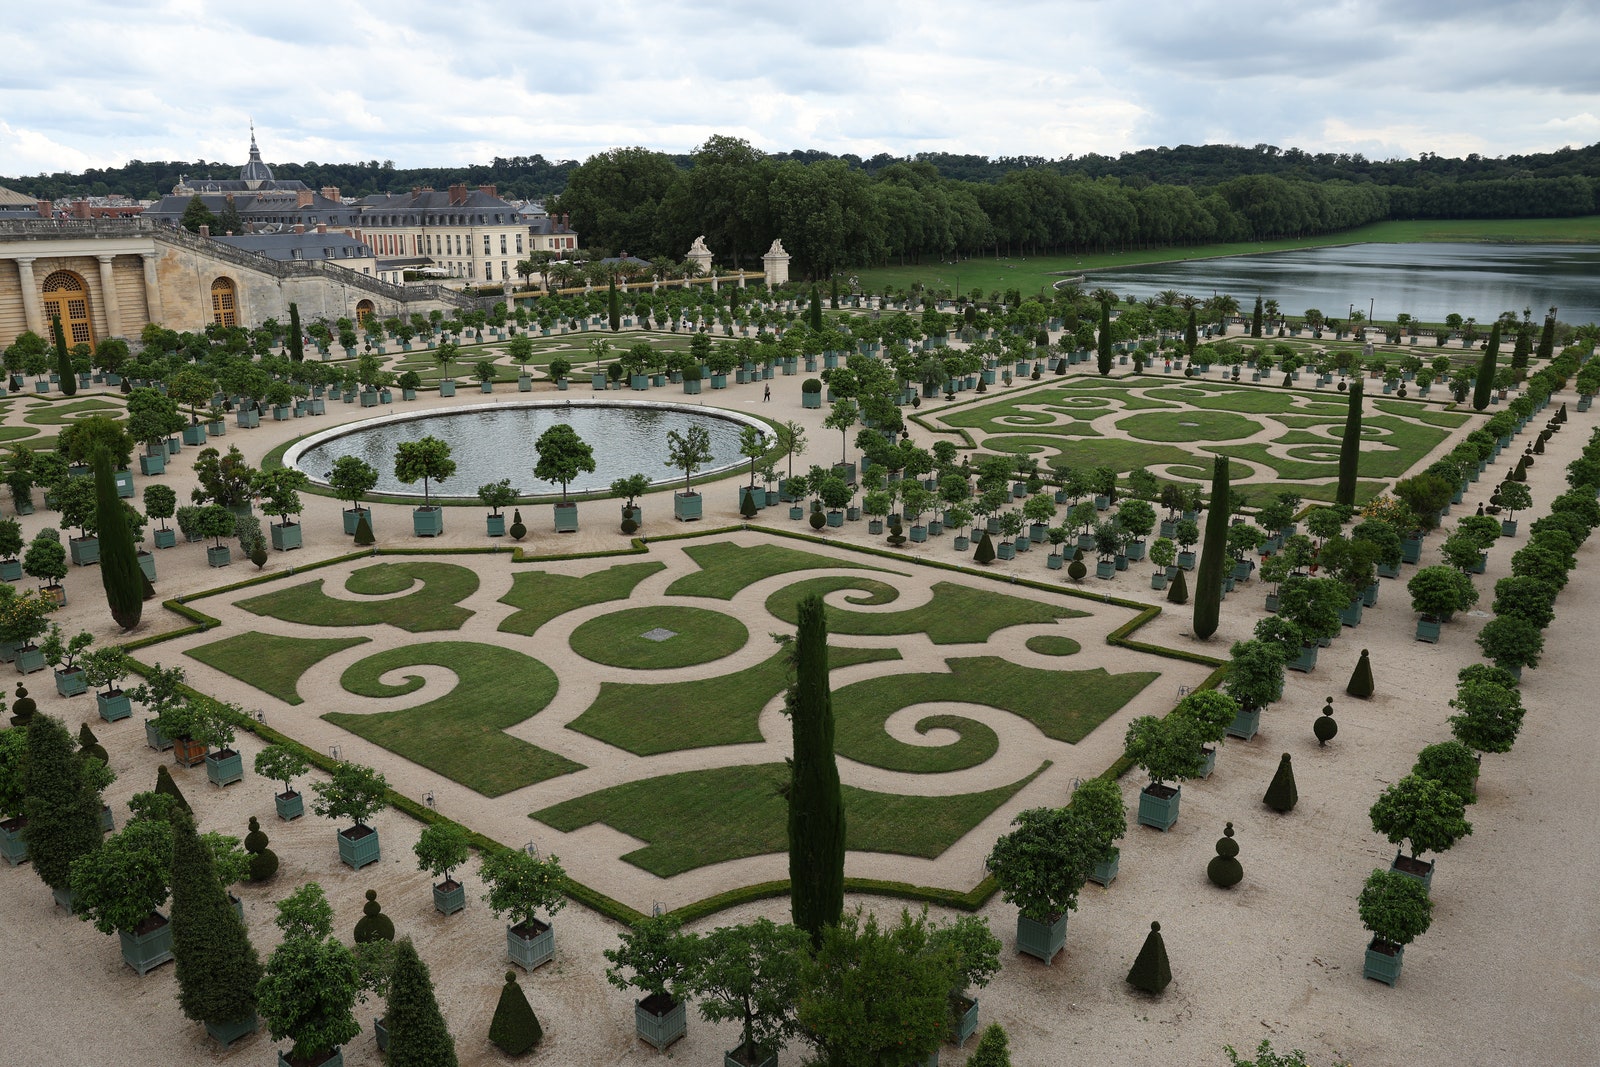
left=0, top=136, right=1600, bottom=277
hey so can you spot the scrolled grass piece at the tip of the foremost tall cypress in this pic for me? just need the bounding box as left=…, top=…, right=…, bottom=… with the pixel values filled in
left=766, top=574, right=1088, bottom=645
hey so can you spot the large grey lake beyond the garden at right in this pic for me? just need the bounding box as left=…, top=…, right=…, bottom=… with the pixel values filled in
left=1085, top=243, right=1600, bottom=325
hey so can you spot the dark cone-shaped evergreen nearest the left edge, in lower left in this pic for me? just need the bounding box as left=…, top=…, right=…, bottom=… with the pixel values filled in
left=22, top=715, right=101, bottom=893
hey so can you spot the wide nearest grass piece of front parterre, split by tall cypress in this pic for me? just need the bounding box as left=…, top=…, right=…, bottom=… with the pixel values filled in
left=531, top=761, right=1050, bottom=878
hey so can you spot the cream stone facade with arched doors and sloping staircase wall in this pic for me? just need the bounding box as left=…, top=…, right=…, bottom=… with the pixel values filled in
left=0, top=219, right=472, bottom=347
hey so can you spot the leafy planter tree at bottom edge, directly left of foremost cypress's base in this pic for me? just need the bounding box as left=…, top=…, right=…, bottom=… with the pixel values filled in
left=690, top=918, right=810, bottom=1067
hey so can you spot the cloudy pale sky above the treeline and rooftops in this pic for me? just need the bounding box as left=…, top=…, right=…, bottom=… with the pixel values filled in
left=0, top=0, right=1600, bottom=176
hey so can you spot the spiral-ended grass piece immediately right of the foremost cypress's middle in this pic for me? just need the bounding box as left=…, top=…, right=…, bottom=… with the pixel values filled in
left=834, top=656, right=1160, bottom=774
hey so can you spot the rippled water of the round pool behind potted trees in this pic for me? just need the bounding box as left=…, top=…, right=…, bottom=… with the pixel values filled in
left=283, top=400, right=770, bottom=498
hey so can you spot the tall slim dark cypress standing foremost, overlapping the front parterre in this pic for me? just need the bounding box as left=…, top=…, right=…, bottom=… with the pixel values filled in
left=789, top=593, right=845, bottom=945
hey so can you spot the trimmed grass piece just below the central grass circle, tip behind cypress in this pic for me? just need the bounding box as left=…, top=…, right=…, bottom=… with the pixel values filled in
left=568, top=646, right=901, bottom=755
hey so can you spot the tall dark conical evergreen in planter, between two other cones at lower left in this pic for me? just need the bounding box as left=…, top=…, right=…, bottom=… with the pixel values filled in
left=173, top=811, right=261, bottom=1027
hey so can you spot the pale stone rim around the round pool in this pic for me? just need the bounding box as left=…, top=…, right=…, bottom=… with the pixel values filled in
left=280, top=397, right=778, bottom=507
